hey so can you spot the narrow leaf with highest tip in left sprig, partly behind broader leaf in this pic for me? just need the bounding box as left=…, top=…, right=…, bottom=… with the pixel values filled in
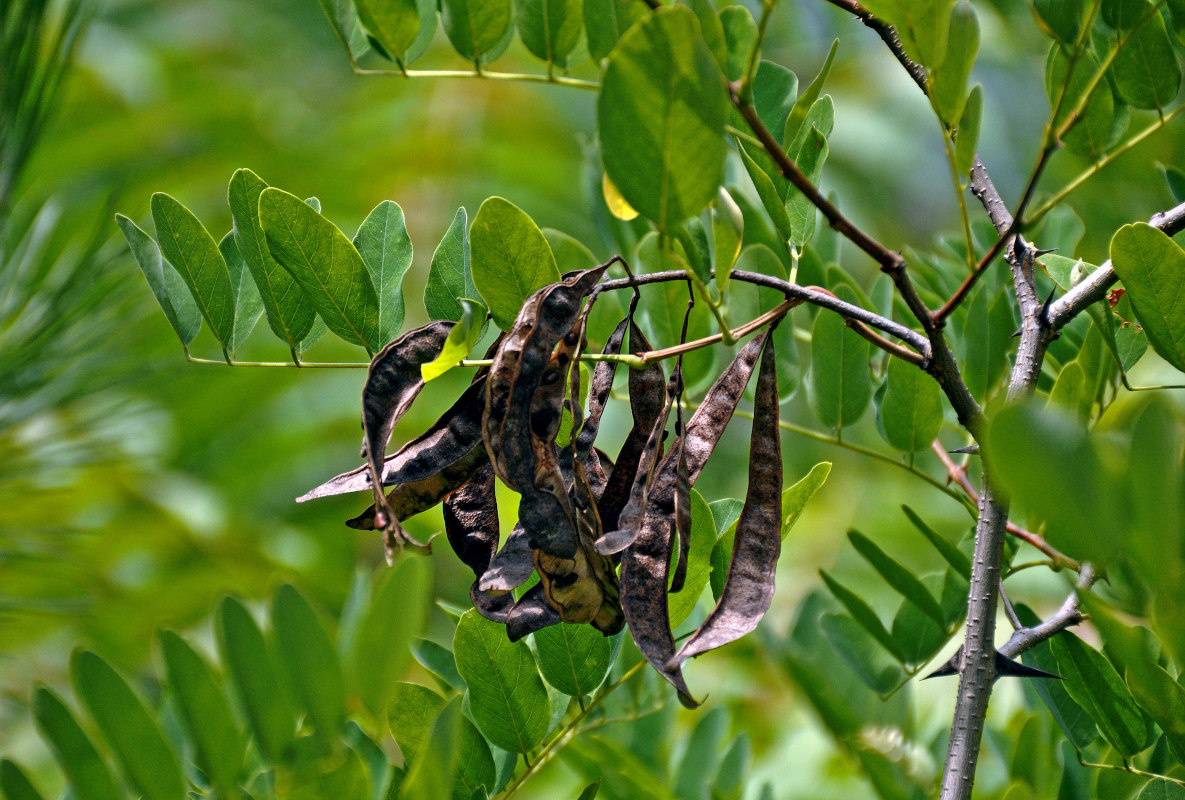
left=226, top=169, right=316, bottom=350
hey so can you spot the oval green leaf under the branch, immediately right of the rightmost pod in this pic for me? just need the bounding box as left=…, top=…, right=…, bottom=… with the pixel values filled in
left=808, top=287, right=872, bottom=429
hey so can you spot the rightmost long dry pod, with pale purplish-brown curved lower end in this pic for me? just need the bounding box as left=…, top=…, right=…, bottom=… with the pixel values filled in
left=667, top=338, right=782, bottom=668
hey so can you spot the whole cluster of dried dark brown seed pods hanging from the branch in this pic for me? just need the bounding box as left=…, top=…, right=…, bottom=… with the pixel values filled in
left=300, top=264, right=782, bottom=706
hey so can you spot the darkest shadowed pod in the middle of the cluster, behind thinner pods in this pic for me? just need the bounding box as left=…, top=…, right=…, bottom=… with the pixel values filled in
left=597, top=319, right=670, bottom=531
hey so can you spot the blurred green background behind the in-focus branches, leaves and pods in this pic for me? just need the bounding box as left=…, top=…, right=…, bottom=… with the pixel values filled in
left=0, top=0, right=1185, bottom=798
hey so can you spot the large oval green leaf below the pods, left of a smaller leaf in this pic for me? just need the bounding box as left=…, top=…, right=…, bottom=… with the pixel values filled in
left=453, top=609, right=551, bottom=753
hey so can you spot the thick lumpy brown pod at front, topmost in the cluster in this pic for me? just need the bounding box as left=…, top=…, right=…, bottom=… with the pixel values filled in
left=482, top=267, right=606, bottom=558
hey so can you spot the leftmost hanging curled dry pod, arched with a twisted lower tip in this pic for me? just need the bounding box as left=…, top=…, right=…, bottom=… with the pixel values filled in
left=363, top=320, right=455, bottom=529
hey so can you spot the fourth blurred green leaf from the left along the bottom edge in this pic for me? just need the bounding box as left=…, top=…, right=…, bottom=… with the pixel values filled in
left=160, top=631, right=246, bottom=796
